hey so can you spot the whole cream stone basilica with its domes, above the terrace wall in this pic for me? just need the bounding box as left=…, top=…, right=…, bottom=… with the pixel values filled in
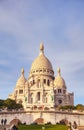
left=8, top=43, right=74, bottom=110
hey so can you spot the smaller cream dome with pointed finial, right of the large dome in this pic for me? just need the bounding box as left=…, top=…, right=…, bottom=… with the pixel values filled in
left=54, top=68, right=66, bottom=88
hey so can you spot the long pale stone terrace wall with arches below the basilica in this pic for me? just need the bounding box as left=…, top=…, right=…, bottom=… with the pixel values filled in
left=0, top=111, right=84, bottom=126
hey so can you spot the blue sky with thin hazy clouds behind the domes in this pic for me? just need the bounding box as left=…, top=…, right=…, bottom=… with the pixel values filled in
left=0, top=0, right=84, bottom=105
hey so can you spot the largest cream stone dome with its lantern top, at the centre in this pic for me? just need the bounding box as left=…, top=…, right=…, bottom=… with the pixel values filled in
left=30, top=43, right=54, bottom=75
